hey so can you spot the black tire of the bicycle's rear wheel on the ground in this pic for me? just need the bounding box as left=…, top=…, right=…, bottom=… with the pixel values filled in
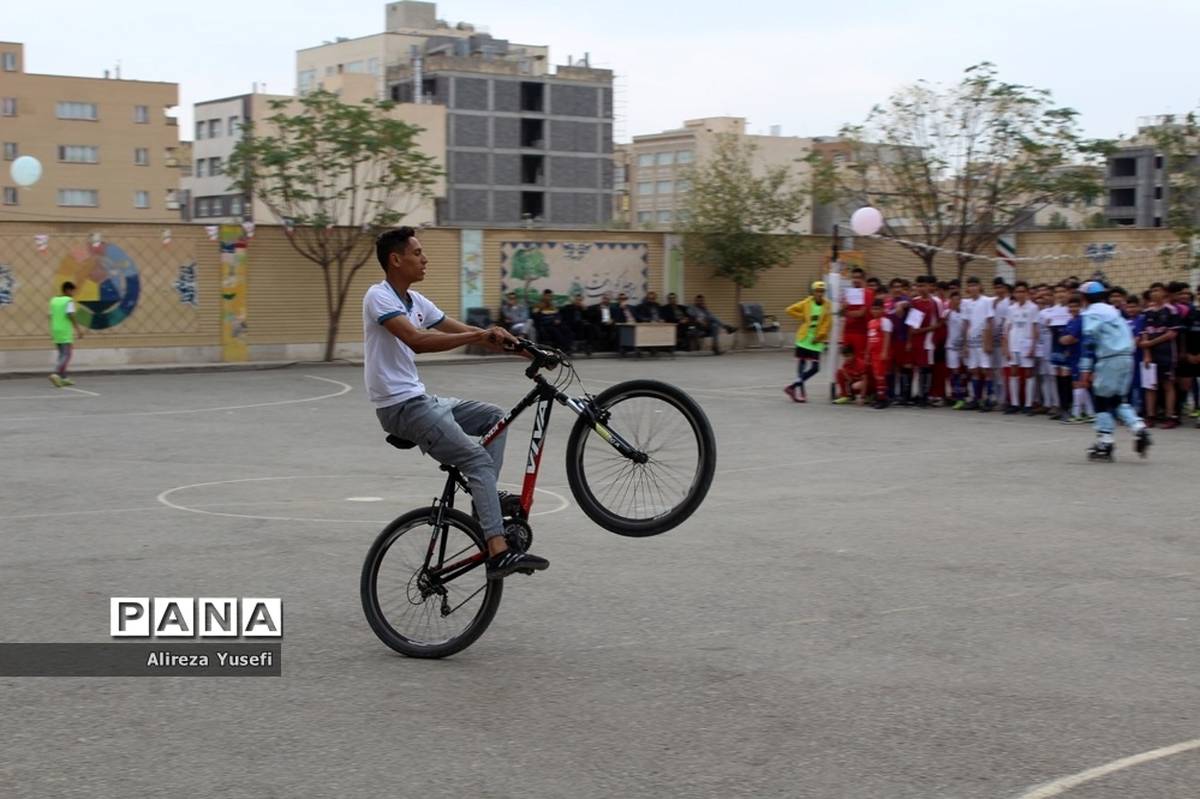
left=360, top=507, right=504, bottom=657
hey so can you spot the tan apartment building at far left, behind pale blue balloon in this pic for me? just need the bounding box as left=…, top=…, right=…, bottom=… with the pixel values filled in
left=0, top=42, right=180, bottom=222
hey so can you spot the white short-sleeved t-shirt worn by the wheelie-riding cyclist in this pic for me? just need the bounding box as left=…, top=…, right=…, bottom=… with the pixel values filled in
left=362, top=281, right=446, bottom=408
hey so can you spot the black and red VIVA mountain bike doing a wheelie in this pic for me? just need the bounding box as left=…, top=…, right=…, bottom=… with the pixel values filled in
left=360, top=338, right=716, bottom=657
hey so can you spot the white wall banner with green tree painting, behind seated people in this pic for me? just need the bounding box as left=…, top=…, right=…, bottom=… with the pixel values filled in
left=500, top=241, right=650, bottom=305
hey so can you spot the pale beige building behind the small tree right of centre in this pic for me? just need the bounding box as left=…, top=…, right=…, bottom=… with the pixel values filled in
left=625, top=116, right=812, bottom=233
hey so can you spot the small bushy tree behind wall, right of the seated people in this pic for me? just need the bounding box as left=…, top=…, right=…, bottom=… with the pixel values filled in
left=677, top=134, right=810, bottom=316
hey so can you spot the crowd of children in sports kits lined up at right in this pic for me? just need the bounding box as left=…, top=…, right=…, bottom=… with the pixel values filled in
left=811, top=270, right=1200, bottom=428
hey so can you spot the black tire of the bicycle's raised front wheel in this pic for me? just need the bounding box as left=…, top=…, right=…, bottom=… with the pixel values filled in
left=566, top=380, right=716, bottom=537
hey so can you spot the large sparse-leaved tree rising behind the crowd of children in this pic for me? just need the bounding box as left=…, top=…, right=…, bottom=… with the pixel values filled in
left=810, top=62, right=1111, bottom=278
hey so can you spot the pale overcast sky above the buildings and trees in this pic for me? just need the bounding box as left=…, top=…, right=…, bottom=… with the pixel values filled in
left=9, top=0, right=1200, bottom=139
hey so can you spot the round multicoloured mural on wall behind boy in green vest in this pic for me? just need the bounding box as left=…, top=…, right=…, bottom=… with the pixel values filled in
left=54, top=242, right=142, bottom=330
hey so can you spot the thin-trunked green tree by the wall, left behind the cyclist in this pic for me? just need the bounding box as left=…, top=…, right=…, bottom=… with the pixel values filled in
left=227, top=91, right=442, bottom=361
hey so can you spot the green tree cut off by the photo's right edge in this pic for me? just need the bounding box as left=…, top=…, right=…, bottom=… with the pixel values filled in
left=1146, top=112, right=1200, bottom=269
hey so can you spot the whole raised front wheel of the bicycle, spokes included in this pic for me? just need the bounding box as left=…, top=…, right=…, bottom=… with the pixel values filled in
left=566, top=380, right=716, bottom=537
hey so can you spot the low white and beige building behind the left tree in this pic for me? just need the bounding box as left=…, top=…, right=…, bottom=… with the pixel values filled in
left=182, top=73, right=446, bottom=226
